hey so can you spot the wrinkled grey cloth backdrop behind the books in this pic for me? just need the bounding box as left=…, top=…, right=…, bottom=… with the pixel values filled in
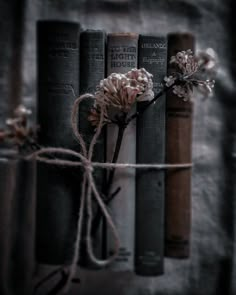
left=0, top=0, right=236, bottom=295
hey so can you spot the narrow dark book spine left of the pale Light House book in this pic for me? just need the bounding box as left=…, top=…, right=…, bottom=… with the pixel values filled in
left=79, top=30, right=106, bottom=267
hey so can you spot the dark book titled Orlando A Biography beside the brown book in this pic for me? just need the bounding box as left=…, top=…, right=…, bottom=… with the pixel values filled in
left=135, top=35, right=167, bottom=276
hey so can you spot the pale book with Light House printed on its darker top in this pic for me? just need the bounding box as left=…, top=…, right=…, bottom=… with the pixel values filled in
left=107, top=33, right=138, bottom=270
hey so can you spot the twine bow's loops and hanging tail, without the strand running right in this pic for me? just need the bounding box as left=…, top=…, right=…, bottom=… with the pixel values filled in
left=28, top=94, right=120, bottom=293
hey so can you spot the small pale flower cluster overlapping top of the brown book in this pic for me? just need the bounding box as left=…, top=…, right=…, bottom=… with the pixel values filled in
left=164, top=49, right=216, bottom=100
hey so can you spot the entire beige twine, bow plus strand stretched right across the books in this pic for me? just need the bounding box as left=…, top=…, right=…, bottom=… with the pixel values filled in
left=28, top=93, right=192, bottom=292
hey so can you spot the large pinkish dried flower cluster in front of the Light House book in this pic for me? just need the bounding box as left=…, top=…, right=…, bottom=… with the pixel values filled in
left=88, top=69, right=154, bottom=126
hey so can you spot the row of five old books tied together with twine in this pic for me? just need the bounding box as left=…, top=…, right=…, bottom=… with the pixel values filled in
left=36, top=21, right=194, bottom=276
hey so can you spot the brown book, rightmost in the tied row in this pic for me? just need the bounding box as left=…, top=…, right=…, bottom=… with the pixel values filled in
left=165, top=33, right=194, bottom=258
